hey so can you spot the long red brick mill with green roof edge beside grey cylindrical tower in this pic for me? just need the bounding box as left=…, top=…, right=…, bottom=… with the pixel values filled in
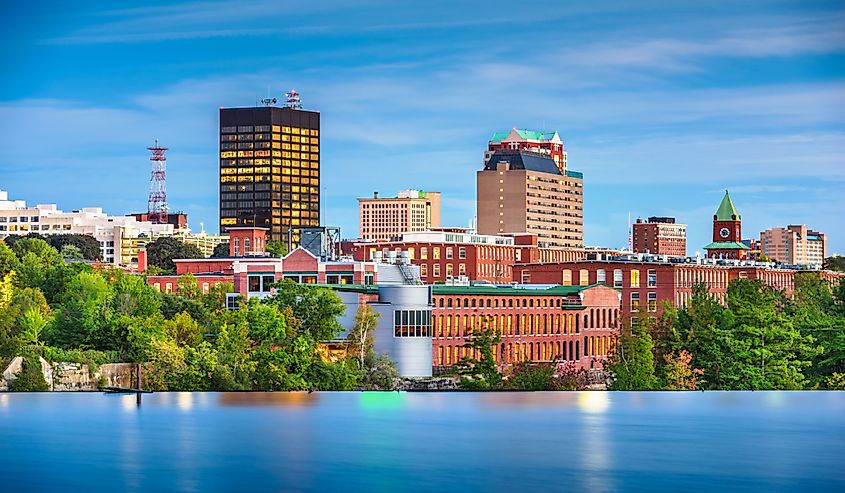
left=432, top=280, right=620, bottom=369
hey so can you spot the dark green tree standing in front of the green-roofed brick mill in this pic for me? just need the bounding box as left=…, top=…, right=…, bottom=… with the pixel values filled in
left=455, top=318, right=502, bottom=390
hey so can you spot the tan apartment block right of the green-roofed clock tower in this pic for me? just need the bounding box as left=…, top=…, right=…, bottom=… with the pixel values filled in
left=760, top=224, right=827, bottom=266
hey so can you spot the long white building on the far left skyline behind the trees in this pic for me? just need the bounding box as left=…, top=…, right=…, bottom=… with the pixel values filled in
left=0, top=190, right=173, bottom=265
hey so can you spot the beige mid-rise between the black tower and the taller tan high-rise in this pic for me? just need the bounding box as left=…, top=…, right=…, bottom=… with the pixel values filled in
left=358, top=190, right=440, bottom=241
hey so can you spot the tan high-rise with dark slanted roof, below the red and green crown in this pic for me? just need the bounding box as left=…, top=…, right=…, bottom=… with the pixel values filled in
left=477, top=150, right=584, bottom=248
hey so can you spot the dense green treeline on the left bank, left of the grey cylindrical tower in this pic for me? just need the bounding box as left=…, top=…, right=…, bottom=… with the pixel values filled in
left=0, top=238, right=396, bottom=391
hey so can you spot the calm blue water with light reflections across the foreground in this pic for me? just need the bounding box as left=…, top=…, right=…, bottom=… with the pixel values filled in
left=0, top=392, right=845, bottom=493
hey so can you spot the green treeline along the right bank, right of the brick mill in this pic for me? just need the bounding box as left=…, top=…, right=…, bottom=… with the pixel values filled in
left=607, top=273, right=845, bottom=390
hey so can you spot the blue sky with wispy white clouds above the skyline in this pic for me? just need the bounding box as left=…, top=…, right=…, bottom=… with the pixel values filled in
left=0, top=0, right=845, bottom=255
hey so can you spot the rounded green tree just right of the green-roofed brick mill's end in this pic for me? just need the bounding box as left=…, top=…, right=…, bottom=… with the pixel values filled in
left=605, top=319, right=657, bottom=390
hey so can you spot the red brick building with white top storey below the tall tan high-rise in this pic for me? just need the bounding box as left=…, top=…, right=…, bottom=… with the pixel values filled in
left=341, top=228, right=584, bottom=284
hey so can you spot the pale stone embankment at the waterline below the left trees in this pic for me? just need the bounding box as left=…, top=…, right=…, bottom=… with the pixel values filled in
left=0, top=356, right=135, bottom=392
